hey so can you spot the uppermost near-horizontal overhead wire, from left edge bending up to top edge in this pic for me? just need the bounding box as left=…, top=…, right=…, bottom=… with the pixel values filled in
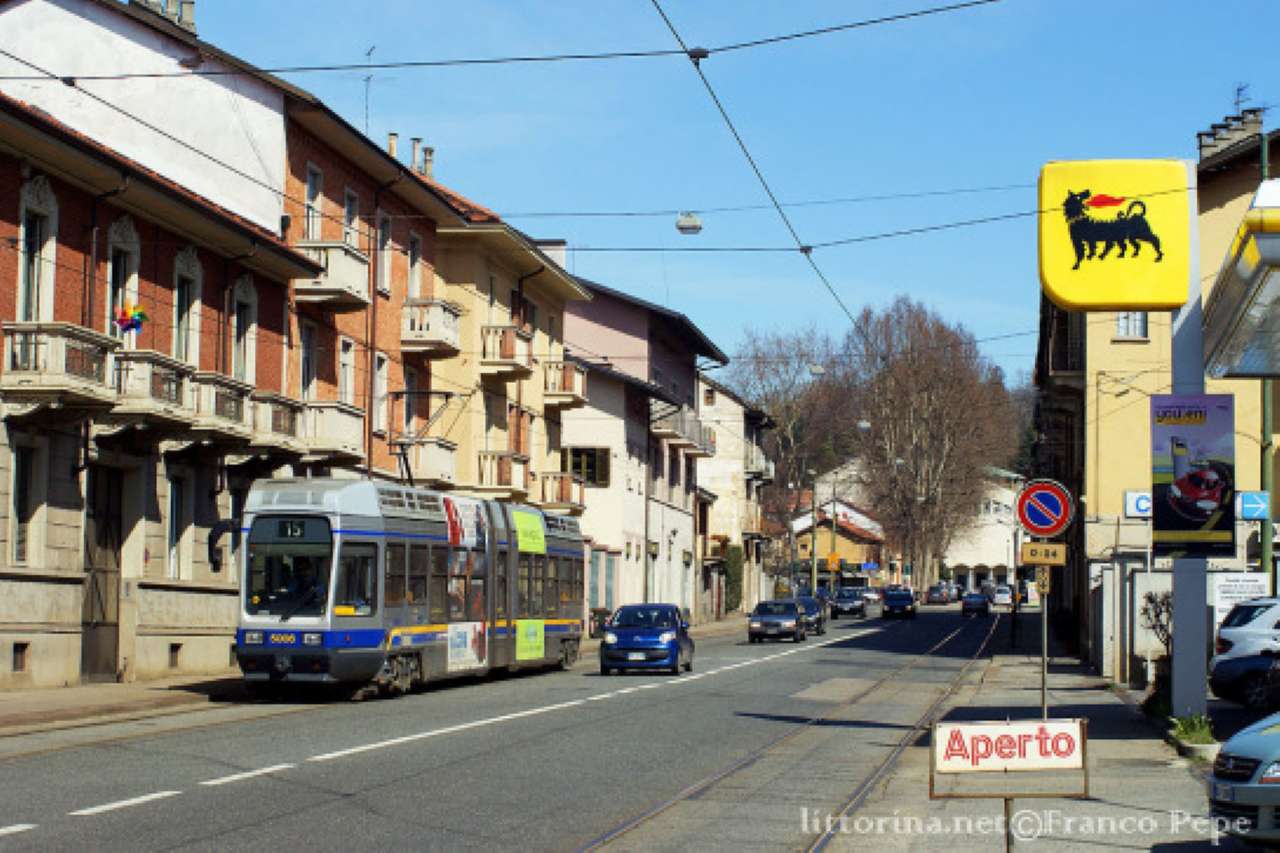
left=0, top=0, right=1000, bottom=85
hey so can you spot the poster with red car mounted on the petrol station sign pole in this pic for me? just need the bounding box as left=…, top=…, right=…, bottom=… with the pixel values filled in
left=1151, top=394, right=1235, bottom=557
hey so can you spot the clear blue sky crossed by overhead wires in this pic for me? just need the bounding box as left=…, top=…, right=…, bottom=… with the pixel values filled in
left=197, top=0, right=1280, bottom=379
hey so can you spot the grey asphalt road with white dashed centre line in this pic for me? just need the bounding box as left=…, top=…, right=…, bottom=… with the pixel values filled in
left=0, top=606, right=991, bottom=850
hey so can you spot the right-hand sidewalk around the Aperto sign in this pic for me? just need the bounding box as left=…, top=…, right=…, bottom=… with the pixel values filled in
left=833, top=611, right=1242, bottom=852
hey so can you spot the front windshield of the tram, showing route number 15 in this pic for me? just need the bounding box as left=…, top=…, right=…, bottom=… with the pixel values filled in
left=244, top=516, right=333, bottom=621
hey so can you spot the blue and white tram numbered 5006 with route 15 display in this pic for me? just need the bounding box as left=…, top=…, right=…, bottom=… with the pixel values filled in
left=236, top=479, right=584, bottom=692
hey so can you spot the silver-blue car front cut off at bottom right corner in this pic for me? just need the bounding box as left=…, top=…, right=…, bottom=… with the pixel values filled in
left=1208, top=713, right=1280, bottom=845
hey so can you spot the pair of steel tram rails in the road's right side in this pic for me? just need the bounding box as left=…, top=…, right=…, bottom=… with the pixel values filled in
left=577, top=613, right=1001, bottom=853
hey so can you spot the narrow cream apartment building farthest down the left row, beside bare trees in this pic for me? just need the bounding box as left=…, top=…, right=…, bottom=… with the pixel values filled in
left=698, top=374, right=774, bottom=611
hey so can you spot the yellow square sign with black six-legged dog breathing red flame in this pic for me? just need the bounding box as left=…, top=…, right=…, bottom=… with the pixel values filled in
left=1039, top=160, right=1196, bottom=311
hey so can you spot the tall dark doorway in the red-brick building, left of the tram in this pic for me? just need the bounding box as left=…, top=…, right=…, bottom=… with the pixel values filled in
left=81, top=465, right=124, bottom=681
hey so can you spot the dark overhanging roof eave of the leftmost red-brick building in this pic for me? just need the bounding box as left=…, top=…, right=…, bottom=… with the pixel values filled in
left=0, top=92, right=324, bottom=278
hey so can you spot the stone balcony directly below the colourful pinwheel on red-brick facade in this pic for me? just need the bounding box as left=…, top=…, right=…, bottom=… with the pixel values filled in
left=108, top=350, right=196, bottom=428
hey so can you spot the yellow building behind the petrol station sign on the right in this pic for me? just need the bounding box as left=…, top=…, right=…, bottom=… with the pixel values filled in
left=1036, top=110, right=1276, bottom=680
